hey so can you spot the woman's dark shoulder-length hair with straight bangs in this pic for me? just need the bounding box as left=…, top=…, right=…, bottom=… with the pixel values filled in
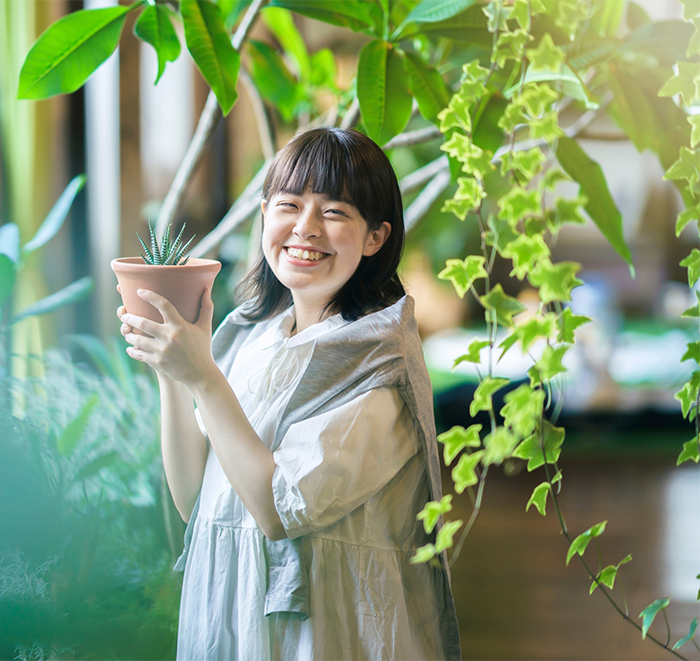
left=237, top=127, right=405, bottom=321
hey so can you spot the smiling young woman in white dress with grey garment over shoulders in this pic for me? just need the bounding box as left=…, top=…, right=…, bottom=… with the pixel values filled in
left=118, top=128, right=461, bottom=661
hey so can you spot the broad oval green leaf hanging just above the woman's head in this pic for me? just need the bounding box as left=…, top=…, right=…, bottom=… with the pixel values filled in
left=357, top=39, right=411, bottom=145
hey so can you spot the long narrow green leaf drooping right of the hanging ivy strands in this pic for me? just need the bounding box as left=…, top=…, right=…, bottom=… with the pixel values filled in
left=557, top=137, right=634, bottom=274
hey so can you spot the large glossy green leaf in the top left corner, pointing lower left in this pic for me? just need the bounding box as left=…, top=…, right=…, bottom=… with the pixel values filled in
left=17, top=2, right=135, bottom=99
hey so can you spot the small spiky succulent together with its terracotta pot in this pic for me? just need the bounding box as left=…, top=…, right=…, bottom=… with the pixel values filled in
left=111, top=221, right=221, bottom=332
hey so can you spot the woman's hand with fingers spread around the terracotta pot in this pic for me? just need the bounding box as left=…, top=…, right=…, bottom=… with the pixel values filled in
left=117, top=289, right=218, bottom=388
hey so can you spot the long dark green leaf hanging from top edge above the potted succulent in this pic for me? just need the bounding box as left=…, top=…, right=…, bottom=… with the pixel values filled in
left=180, top=0, right=241, bottom=115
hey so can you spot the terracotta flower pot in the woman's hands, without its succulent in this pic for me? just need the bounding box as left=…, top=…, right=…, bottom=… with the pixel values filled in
left=111, top=257, right=221, bottom=330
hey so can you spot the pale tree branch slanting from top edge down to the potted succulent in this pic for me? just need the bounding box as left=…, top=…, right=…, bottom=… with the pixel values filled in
left=155, top=0, right=268, bottom=237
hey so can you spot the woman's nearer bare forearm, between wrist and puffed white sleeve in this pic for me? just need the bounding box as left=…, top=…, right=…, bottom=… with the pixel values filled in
left=192, top=369, right=286, bottom=540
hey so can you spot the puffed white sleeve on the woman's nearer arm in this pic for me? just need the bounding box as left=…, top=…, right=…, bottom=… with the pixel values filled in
left=272, top=387, right=418, bottom=539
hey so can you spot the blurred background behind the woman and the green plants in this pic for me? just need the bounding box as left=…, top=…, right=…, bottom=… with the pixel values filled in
left=0, top=0, right=700, bottom=661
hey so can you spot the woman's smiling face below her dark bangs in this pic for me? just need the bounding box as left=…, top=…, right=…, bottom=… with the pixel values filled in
left=262, top=188, right=391, bottom=313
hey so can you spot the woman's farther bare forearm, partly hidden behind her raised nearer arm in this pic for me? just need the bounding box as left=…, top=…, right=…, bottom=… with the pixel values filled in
left=158, top=373, right=208, bottom=522
